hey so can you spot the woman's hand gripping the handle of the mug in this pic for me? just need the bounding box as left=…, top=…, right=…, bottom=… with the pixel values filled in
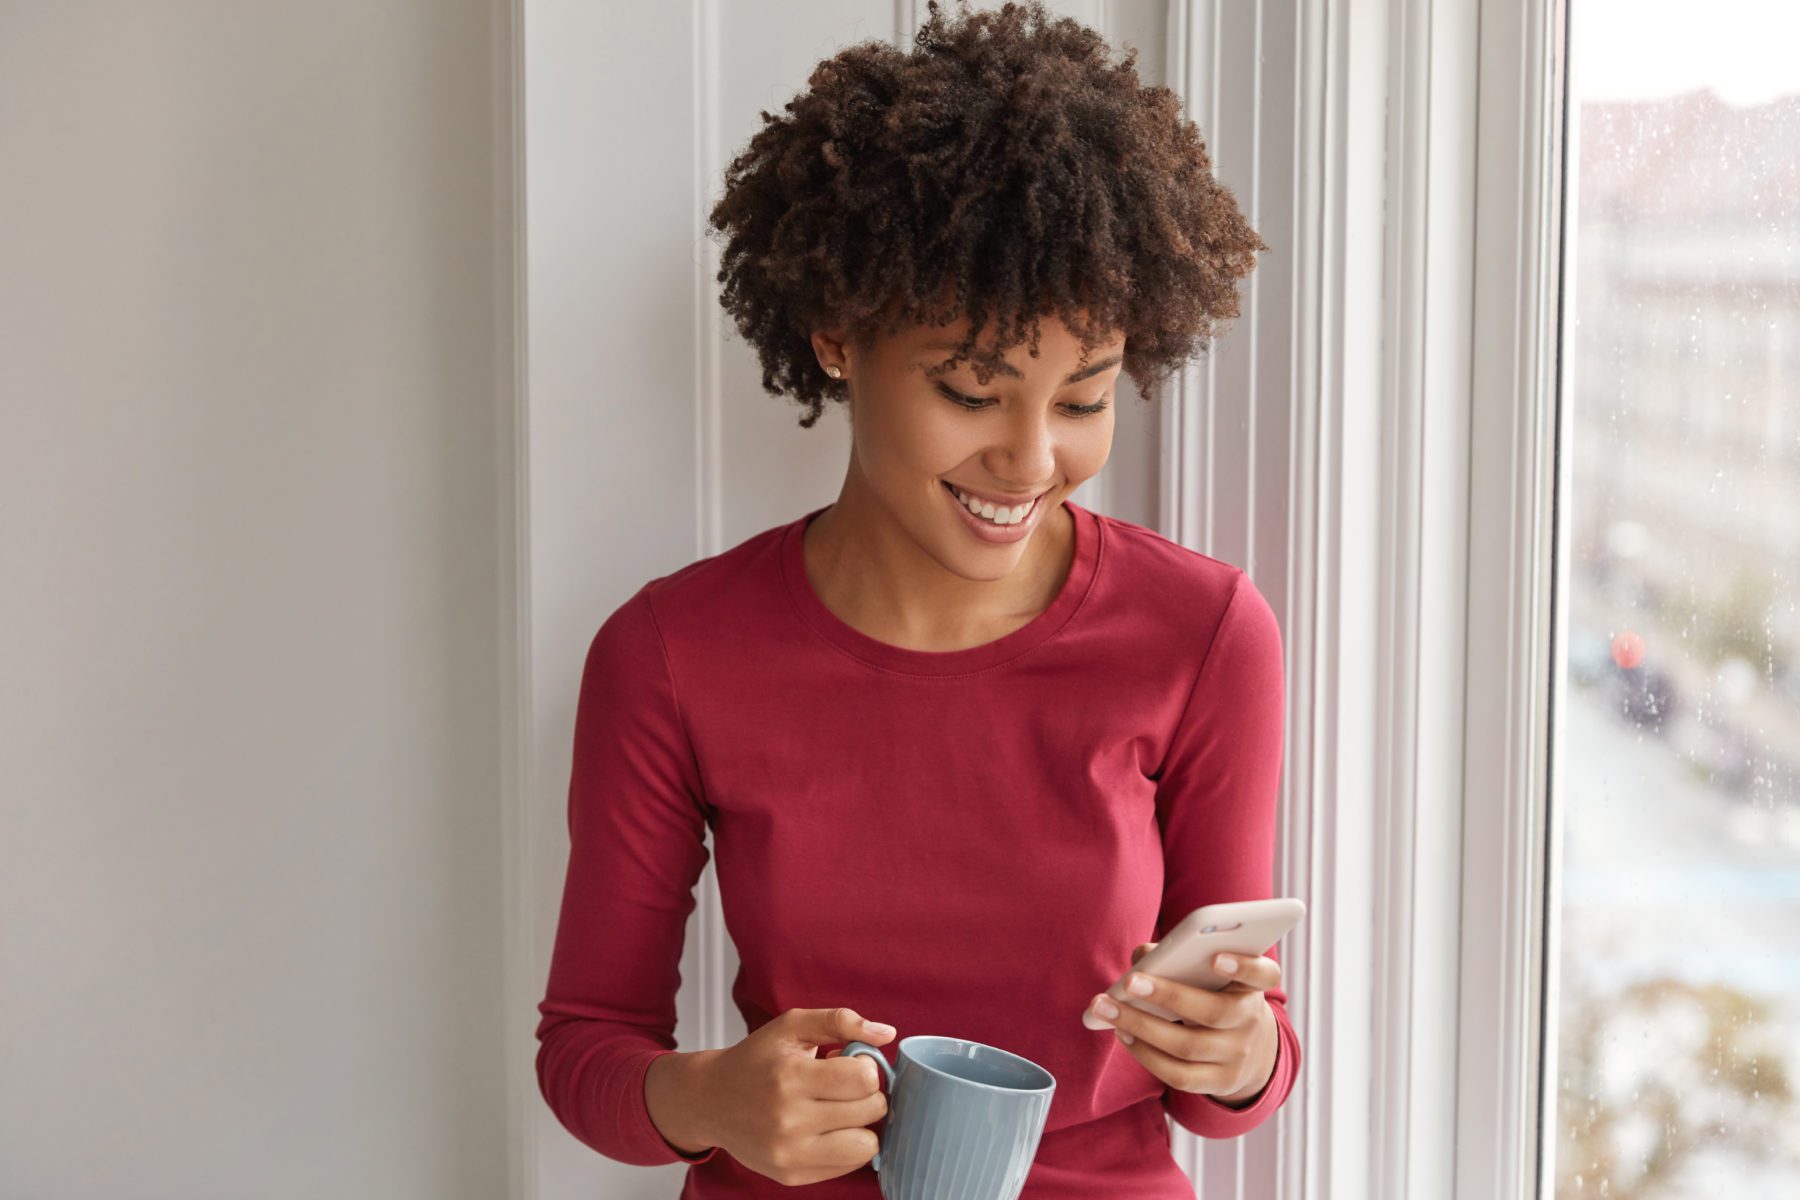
left=704, top=1007, right=895, bottom=1187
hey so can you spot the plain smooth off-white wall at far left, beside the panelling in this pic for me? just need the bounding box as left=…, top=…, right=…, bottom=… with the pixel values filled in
left=0, top=0, right=509, bottom=1200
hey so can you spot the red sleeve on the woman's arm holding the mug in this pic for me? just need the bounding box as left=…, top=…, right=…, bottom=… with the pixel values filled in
left=536, top=585, right=718, bottom=1166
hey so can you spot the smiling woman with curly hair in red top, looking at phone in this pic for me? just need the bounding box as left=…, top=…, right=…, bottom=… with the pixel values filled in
left=538, top=4, right=1300, bottom=1200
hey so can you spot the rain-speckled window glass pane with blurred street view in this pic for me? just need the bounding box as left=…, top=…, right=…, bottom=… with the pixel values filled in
left=1544, top=0, right=1800, bottom=1200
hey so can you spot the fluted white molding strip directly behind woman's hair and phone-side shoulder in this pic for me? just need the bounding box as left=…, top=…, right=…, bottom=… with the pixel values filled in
left=1157, top=0, right=1321, bottom=1196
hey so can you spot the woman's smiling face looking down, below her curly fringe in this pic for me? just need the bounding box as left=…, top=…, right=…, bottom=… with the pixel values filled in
left=819, top=317, right=1125, bottom=579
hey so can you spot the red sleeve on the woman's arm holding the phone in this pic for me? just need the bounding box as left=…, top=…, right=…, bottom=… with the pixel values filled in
left=1152, top=572, right=1300, bottom=1137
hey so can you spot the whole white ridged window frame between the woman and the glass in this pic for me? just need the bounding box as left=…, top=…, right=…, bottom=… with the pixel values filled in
left=1159, top=0, right=1566, bottom=1200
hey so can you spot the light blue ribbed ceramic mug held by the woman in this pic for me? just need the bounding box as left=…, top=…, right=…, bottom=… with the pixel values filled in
left=841, top=1034, right=1057, bottom=1200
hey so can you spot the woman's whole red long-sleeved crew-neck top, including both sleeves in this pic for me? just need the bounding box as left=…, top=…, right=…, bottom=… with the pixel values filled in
left=536, top=500, right=1300, bottom=1200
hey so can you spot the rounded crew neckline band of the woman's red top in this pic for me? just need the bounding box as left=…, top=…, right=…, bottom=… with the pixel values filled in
left=781, top=498, right=1105, bottom=675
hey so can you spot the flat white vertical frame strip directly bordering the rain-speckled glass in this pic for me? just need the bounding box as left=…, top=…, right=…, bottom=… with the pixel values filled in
left=1454, top=0, right=1570, bottom=1200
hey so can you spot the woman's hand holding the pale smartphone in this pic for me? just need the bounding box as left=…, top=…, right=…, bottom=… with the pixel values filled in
left=1089, top=941, right=1282, bottom=1108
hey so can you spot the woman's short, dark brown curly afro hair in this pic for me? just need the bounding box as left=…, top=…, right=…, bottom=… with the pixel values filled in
left=709, top=0, right=1269, bottom=428
